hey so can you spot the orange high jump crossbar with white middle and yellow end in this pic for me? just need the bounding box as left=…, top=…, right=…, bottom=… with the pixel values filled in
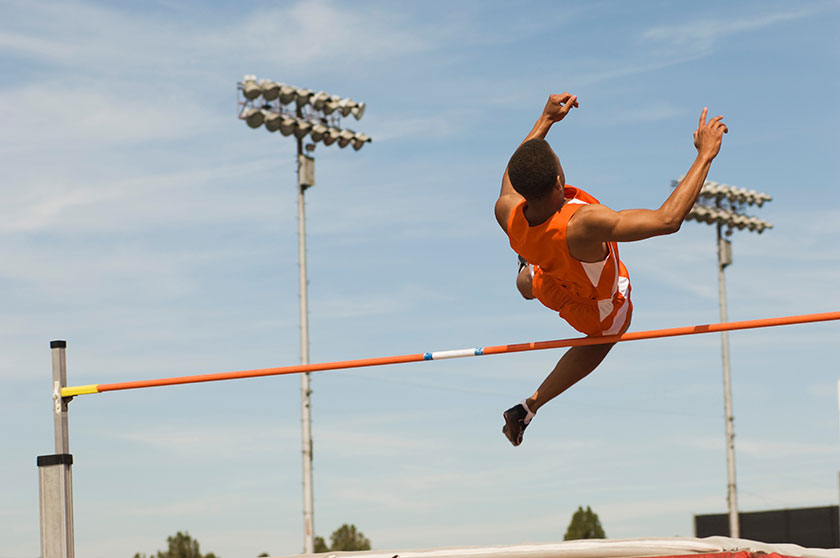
left=61, top=312, right=840, bottom=397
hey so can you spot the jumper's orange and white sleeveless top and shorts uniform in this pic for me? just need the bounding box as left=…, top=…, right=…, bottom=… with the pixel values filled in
left=508, top=185, right=631, bottom=336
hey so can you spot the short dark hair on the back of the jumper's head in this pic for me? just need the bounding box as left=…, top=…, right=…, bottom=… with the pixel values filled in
left=508, top=138, right=559, bottom=200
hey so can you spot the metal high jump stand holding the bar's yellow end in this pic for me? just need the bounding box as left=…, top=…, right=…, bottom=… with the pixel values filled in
left=38, top=341, right=75, bottom=558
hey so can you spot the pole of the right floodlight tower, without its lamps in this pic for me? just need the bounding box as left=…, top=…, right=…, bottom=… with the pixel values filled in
left=717, top=224, right=741, bottom=538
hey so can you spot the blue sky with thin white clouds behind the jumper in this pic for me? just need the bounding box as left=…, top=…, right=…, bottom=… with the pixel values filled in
left=0, top=0, right=840, bottom=558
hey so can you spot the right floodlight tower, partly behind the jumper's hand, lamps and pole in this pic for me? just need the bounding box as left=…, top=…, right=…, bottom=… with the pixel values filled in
left=671, top=180, right=773, bottom=538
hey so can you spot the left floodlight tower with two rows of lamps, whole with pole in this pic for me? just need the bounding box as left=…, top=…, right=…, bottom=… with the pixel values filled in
left=237, top=75, right=371, bottom=554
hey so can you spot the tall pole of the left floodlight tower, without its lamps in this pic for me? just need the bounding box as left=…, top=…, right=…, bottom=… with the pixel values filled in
left=297, top=132, right=315, bottom=554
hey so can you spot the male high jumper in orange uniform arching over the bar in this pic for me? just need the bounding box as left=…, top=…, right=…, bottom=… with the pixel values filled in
left=495, top=93, right=727, bottom=446
